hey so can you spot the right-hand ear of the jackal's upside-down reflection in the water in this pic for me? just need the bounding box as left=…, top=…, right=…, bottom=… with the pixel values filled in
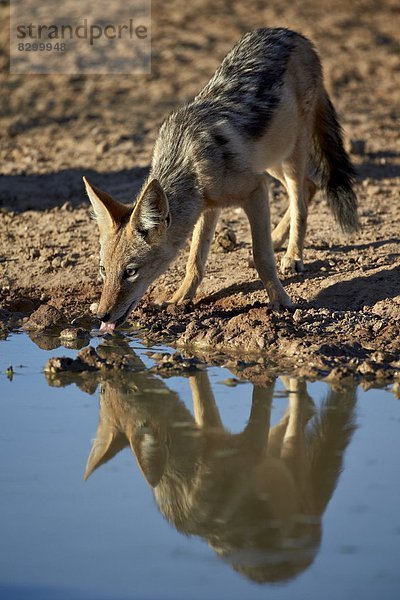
left=129, top=427, right=168, bottom=488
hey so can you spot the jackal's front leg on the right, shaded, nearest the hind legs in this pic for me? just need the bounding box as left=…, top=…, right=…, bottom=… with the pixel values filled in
left=243, top=179, right=291, bottom=308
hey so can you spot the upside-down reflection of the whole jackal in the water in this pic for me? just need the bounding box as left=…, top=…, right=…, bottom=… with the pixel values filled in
left=85, top=356, right=356, bottom=582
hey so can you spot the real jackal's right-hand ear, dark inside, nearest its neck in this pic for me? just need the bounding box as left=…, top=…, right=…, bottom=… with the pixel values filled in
left=131, top=179, right=171, bottom=233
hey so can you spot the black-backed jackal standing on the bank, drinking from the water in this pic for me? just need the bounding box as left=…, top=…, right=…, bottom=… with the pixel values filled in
left=85, top=28, right=358, bottom=330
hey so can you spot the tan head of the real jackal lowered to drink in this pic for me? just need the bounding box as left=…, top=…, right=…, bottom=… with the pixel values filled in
left=84, top=178, right=173, bottom=331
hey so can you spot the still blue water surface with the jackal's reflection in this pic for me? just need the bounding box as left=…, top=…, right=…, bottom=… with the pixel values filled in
left=0, top=335, right=400, bottom=600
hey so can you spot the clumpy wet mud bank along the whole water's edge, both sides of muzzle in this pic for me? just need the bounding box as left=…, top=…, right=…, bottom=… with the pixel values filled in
left=0, top=288, right=400, bottom=387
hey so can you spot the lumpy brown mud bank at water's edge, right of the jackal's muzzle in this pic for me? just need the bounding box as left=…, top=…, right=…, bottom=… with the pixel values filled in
left=135, top=302, right=400, bottom=381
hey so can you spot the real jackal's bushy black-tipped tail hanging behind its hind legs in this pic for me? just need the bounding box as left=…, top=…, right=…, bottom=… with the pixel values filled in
left=310, top=91, right=359, bottom=232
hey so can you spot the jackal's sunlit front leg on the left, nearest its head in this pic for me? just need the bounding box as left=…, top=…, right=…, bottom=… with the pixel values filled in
left=171, top=209, right=220, bottom=304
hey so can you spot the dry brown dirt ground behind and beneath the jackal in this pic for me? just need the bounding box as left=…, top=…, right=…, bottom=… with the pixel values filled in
left=0, top=0, right=400, bottom=382
